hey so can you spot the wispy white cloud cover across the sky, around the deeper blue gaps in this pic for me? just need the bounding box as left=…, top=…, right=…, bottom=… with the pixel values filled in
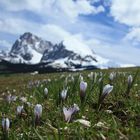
left=0, top=0, right=140, bottom=65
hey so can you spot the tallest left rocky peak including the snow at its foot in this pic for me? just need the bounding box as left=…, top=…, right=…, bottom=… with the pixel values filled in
left=6, top=33, right=53, bottom=64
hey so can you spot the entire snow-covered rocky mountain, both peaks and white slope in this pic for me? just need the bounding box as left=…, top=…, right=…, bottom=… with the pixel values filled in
left=0, top=32, right=109, bottom=70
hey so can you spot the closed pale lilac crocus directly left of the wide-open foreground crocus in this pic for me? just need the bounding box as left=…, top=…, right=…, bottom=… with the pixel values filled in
left=34, top=104, right=42, bottom=125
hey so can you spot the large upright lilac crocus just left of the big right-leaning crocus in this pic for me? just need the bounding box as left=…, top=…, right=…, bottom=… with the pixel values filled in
left=80, top=81, right=87, bottom=103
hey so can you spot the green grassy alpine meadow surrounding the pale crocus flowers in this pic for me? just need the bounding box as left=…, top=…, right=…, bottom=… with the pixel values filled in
left=0, top=68, right=140, bottom=140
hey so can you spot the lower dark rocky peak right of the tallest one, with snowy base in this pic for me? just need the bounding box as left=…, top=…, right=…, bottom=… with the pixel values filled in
left=41, top=42, right=97, bottom=68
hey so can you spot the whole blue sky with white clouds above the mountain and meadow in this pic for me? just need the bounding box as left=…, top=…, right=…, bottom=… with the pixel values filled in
left=0, top=0, right=140, bottom=66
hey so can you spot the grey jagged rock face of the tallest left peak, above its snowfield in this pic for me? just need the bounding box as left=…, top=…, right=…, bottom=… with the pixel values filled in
left=10, top=33, right=53, bottom=61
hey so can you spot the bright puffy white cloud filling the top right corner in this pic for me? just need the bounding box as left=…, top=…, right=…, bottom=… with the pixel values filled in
left=111, top=0, right=140, bottom=26
